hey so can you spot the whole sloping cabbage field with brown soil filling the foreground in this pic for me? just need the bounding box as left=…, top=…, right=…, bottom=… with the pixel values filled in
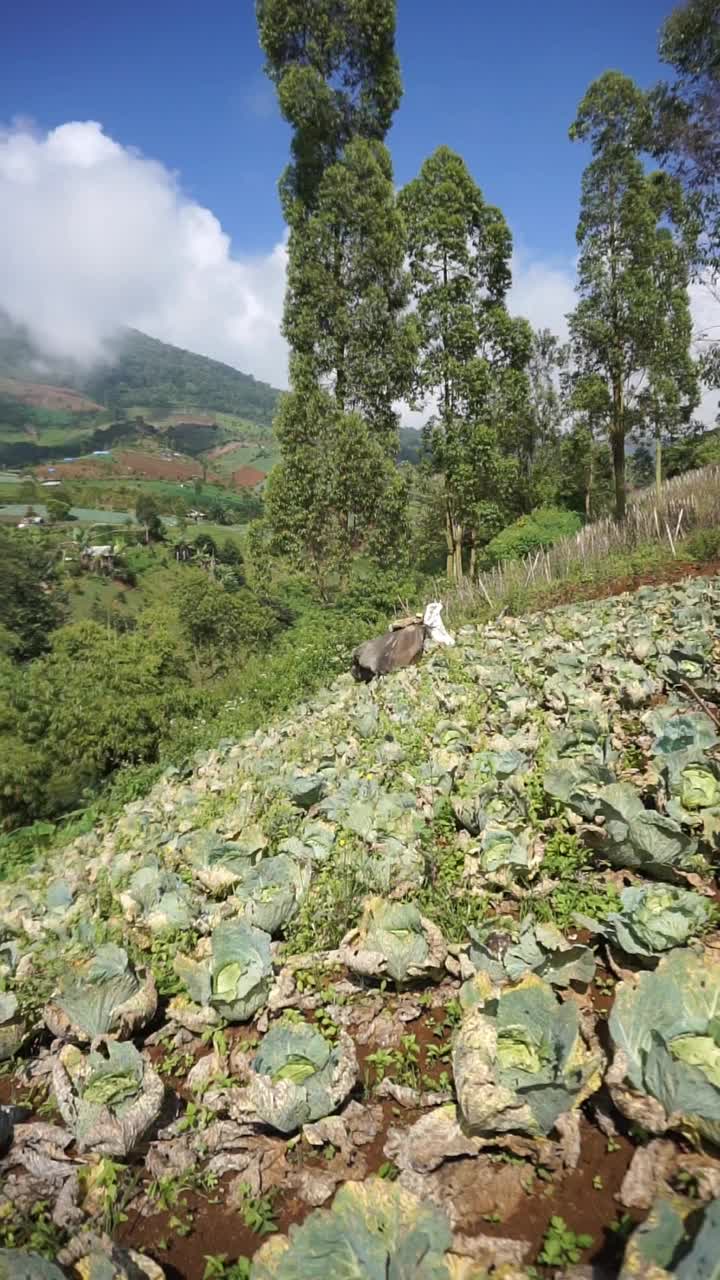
left=0, top=577, right=720, bottom=1280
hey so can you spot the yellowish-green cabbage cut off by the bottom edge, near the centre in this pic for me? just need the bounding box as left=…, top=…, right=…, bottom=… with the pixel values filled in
left=251, top=1178, right=451, bottom=1280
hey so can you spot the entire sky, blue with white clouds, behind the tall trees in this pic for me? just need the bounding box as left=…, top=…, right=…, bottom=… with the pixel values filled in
left=0, top=0, right=702, bottom=399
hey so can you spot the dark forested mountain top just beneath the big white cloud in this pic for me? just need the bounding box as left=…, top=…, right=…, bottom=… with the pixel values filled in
left=0, top=314, right=281, bottom=428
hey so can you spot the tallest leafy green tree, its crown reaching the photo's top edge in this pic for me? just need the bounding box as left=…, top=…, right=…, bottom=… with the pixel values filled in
left=258, top=0, right=415, bottom=595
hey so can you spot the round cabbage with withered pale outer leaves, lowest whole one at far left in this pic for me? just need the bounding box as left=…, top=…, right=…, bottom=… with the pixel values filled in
left=53, top=1039, right=165, bottom=1156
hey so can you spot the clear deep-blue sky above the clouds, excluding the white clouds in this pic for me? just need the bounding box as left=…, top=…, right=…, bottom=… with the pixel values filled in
left=0, top=0, right=671, bottom=259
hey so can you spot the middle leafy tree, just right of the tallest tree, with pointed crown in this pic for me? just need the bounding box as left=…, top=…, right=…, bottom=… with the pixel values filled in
left=400, top=147, right=530, bottom=580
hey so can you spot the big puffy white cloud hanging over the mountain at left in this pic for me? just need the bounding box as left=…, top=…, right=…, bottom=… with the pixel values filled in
left=0, top=120, right=287, bottom=387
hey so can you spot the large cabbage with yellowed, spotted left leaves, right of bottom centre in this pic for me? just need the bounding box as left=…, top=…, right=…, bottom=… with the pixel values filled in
left=452, top=974, right=603, bottom=1135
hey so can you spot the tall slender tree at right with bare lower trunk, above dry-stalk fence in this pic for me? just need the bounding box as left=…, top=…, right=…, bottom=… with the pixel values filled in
left=570, top=72, right=700, bottom=520
